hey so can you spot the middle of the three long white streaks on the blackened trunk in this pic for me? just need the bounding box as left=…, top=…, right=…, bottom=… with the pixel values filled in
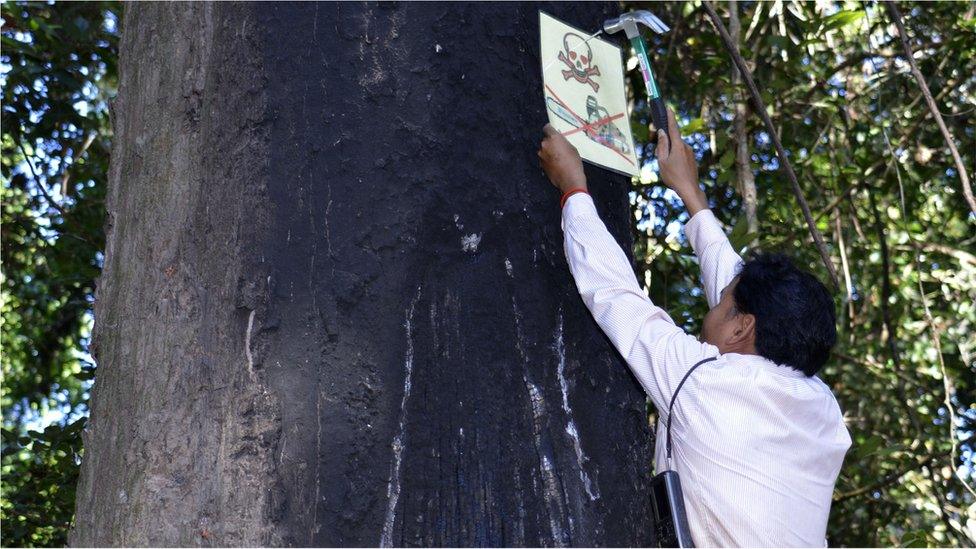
left=512, top=297, right=568, bottom=547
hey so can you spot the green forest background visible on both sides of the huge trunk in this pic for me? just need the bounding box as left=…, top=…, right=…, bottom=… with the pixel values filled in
left=0, top=0, right=976, bottom=546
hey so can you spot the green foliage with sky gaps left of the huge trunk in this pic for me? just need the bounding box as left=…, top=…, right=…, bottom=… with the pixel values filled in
left=0, top=2, right=119, bottom=546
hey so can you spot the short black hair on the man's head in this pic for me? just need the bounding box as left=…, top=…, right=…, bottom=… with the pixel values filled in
left=732, top=254, right=837, bottom=376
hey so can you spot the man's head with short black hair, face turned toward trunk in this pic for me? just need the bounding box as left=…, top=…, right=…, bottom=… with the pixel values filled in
left=702, top=254, right=837, bottom=376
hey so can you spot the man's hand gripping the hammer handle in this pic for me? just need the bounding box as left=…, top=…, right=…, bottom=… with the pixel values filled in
left=657, top=109, right=708, bottom=216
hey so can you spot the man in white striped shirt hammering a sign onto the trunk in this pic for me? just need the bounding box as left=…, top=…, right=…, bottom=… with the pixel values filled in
left=539, top=109, right=851, bottom=547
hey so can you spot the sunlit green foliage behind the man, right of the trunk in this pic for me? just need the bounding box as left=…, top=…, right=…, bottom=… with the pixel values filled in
left=628, top=0, right=976, bottom=546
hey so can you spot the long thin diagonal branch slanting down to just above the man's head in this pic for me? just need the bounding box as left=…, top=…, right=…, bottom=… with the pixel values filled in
left=702, top=1, right=840, bottom=289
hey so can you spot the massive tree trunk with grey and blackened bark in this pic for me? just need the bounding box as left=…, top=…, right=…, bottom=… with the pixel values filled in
left=72, top=3, right=653, bottom=546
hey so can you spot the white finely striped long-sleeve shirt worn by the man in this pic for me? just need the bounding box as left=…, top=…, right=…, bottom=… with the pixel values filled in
left=562, top=193, right=851, bottom=547
